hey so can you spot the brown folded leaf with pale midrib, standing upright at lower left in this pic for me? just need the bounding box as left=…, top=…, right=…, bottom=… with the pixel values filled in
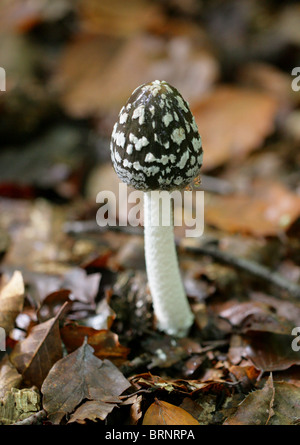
left=10, top=303, right=67, bottom=388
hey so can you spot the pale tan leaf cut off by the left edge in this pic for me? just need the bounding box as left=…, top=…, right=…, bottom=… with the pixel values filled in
left=0, top=271, right=24, bottom=334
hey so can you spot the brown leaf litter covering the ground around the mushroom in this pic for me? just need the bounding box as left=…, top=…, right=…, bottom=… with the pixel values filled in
left=0, top=0, right=300, bottom=425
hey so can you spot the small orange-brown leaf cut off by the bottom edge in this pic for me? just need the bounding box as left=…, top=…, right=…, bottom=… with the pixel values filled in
left=143, top=399, right=199, bottom=425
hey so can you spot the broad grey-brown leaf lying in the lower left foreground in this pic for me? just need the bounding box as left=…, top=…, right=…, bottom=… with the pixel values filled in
left=42, top=341, right=130, bottom=424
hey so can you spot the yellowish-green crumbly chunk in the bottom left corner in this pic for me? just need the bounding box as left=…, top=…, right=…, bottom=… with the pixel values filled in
left=0, top=388, right=41, bottom=425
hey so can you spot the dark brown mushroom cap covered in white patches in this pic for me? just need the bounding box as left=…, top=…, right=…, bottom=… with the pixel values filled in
left=110, top=80, right=203, bottom=191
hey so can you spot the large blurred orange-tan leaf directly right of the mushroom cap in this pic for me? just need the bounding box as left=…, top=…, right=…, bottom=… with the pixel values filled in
left=192, top=86, right=278, bottom=170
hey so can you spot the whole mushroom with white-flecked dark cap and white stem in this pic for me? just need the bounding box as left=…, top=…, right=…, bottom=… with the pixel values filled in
left=110, top=80, right=203, bottom=337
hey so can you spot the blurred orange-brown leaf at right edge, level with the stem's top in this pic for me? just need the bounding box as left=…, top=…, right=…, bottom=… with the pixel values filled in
left=205, top=180, right=300, bottom=236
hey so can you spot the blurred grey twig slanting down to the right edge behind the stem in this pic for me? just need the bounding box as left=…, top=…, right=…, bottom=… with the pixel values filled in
left=182, top=246, right=300, bottom=298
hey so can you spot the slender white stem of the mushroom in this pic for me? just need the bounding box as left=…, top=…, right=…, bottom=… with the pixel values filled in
left=144, top=192, right=194, bottom=337
